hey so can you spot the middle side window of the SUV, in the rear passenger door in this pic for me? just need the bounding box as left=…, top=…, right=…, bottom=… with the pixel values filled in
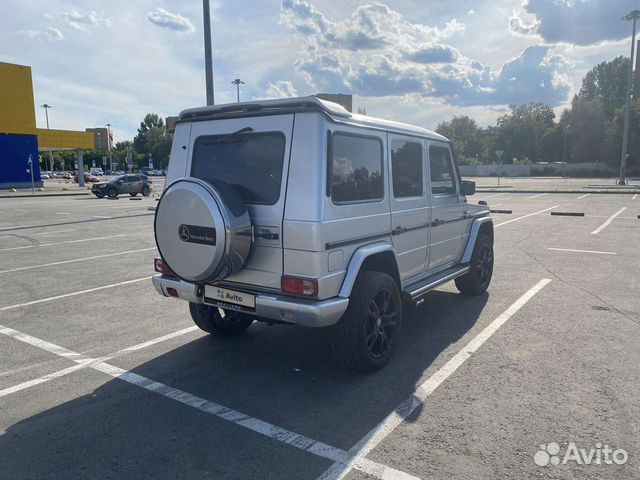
left=391, top=140, right=422, bottom=198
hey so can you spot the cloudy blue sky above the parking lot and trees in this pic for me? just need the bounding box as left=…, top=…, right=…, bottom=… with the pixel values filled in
left=0, top=0, right=640, bottom=141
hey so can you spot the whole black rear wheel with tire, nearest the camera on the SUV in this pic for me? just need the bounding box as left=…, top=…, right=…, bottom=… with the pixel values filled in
left=331, top=271, right=402, bottom=372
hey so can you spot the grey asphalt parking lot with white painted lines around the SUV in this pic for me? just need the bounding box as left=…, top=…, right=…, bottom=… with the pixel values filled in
left=0, top=192, right=640, bottom=480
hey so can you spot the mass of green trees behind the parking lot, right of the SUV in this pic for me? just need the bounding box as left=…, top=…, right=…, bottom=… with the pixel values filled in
left=436, top=56, right=640, bottom=175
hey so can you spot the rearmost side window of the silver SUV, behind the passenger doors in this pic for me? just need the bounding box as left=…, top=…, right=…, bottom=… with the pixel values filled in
left=329, top=133, right=384, bottom=204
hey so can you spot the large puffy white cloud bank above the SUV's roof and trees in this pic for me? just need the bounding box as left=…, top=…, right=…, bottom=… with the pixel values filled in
left=282, top=0, right=569, bottom=106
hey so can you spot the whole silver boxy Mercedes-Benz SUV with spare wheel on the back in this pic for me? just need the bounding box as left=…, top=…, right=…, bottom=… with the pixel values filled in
left=153, top=97, right=493, bottom=370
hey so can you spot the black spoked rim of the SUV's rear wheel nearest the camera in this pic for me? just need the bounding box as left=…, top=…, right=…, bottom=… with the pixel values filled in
left=366, top=289, right=398, bottom=358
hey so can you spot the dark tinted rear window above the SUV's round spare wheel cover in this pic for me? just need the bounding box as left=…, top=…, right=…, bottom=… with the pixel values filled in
left=191, top=132, right=285, bottom=205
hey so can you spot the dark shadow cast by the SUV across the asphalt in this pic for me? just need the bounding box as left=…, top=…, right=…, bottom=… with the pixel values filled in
left=0, top=291, right=489, bottom=478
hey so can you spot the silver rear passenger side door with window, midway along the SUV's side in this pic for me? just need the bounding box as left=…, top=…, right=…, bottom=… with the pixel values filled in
left=387, top=133, right=429, bottom=280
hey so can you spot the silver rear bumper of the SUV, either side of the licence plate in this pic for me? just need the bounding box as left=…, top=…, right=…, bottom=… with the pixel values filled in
left=151, top=275, right=349, bottom=327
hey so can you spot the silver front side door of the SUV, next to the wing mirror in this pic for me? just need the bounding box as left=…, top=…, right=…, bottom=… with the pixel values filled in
left=428, top=142, right=466, bottom=271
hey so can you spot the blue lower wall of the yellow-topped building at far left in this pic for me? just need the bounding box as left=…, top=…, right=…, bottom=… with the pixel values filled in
left=0, top=133, right=42, bottom=188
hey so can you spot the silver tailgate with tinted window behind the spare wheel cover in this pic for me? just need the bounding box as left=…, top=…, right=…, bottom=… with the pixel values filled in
left=185, top=114, right=294, bottom=291
